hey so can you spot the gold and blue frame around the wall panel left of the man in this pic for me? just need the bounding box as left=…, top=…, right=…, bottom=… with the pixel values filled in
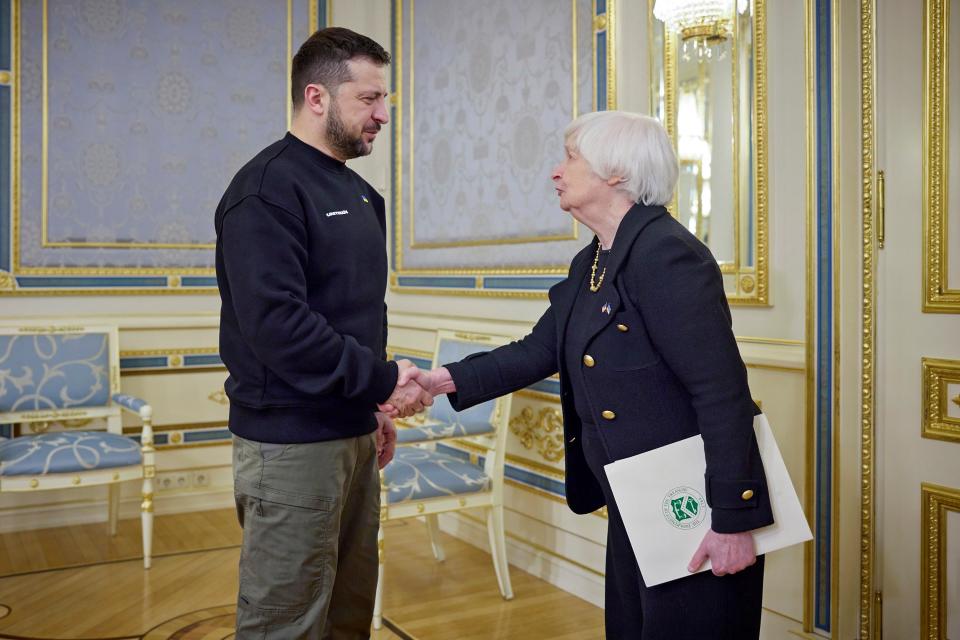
left=0, top=0, right=331, bottom=296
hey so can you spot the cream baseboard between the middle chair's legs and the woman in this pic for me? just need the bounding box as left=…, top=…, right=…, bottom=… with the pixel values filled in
left=440, top=513, right=604, bottom=607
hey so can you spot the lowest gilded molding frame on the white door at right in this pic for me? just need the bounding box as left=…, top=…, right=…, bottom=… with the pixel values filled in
left=920, top=483, right=960, bottom=640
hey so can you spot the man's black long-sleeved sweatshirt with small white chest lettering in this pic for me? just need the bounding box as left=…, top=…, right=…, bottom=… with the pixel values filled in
left=215, top=133, right=397, bottom=443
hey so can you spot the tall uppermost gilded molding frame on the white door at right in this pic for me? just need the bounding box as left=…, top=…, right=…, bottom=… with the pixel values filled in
left=923, top=0, right=960, bottom=313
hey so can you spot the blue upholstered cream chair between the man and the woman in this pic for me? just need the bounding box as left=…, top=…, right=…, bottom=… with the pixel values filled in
left=373, top=331, right=513, bottom=629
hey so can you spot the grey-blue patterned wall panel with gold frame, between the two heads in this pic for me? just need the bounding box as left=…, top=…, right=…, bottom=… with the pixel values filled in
left=393, top=0, right=614, bottom=295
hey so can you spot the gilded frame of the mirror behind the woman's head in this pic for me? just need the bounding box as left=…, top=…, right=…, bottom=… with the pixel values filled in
left=647, top=0, right=770, bottom=306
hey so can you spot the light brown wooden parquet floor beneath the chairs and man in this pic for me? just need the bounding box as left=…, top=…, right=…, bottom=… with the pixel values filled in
left=0, top=510, right=603, bottom=640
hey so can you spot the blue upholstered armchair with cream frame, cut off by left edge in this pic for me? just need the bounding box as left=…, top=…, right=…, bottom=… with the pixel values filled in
left=0, top=325, right=155, bottom=569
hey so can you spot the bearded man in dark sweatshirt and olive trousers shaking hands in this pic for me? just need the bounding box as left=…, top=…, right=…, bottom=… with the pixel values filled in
left=216, top=28, right=432, bottom=640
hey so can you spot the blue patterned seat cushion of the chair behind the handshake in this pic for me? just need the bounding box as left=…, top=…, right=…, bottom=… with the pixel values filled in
left=384, top=447, right=490, bottom=504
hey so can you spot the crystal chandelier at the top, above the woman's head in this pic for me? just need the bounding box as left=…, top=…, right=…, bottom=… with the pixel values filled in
left=653, top=0, right=751, bottom=58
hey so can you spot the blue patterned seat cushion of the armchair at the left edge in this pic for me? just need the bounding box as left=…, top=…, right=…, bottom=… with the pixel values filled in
left=0, top=431, right=141, bottom=476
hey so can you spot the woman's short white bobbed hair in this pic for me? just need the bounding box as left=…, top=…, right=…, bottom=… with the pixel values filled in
left=563, top=111, right=679, bottom=205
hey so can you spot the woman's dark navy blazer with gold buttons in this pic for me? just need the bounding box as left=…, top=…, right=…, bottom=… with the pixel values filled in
left=445, top=204, right=773, bottom=533
